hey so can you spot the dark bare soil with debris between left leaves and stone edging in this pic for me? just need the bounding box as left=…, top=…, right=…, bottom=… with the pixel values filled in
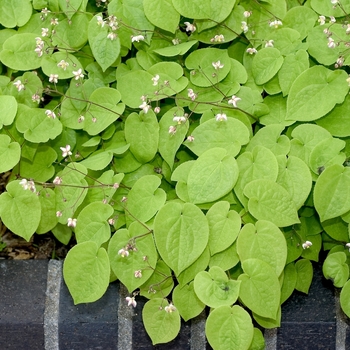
left=0, top=172, right=73, bottom=260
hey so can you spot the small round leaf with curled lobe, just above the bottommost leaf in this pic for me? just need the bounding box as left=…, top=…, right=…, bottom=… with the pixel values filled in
left=194, top=266, right=241, bottom=308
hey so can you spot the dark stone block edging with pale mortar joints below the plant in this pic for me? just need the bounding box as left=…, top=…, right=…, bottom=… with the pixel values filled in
left=0, top=260, right=350, bottom=350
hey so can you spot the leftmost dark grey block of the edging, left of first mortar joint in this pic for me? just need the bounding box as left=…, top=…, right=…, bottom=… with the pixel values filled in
left=0, top=260, right=48, bottom=350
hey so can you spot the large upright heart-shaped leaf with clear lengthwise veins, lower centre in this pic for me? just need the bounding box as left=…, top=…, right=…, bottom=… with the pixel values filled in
left=154, top=202, right=209, bottom=275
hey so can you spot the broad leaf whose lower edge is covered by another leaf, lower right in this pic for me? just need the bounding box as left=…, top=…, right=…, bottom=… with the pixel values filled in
left=237, top=220, right=287, bottom=276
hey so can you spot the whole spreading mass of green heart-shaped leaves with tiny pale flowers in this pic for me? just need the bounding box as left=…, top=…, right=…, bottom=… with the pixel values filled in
left=0, top=0, right=350, bottom=349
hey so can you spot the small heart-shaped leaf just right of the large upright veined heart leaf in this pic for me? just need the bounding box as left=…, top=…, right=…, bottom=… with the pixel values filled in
left=206, top=201, right=241, bottom=256
